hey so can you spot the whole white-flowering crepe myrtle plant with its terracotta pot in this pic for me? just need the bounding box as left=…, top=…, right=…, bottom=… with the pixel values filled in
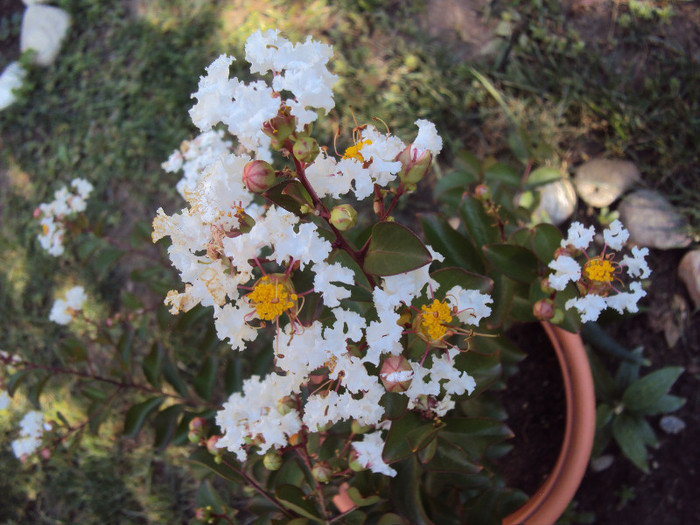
left=3, top=27, right=648, bottom=525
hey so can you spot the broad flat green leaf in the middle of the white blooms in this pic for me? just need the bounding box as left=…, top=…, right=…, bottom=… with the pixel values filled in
left=364, top=222, right=431, bottom=276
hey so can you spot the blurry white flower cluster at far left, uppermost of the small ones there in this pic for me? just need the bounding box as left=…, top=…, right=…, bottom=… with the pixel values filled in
left=34, top=178, right=93, bottom=257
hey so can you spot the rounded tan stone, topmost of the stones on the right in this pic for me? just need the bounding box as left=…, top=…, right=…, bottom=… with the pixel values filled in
left=574, top=159, right=640, bottom=208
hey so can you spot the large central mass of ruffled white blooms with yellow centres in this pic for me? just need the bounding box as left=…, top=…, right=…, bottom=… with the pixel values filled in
left=152, top=31, right=491, bottom=475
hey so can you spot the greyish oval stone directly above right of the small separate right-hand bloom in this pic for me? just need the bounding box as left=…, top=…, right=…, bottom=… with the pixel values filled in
left=618, top=190, right=691, bottom=250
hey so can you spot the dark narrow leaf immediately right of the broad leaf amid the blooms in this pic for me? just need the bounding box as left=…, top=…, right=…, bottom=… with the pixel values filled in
left=420, top=214, right=484, bottom=273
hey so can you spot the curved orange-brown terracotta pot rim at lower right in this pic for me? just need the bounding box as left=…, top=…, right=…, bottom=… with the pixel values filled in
left=503, top=323, right=595, bottom=525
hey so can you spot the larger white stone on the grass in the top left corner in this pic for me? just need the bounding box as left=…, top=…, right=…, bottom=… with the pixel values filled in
left=19, top=4, right=70, bottom=66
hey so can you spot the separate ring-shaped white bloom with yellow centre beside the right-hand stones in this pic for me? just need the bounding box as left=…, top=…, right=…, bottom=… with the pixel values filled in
left=549, top=220, right=651, bottom=322
